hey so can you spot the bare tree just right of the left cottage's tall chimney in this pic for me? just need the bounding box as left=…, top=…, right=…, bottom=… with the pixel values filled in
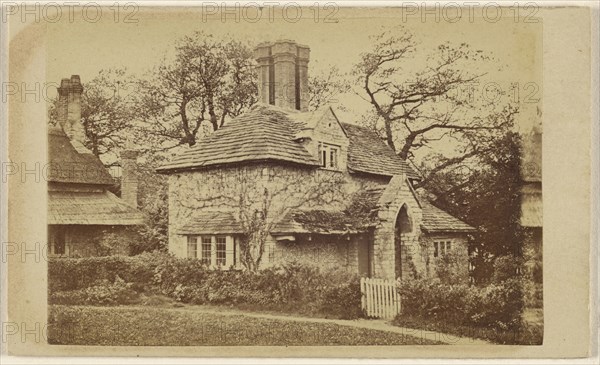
left=50, top=69, right=137, bottom=158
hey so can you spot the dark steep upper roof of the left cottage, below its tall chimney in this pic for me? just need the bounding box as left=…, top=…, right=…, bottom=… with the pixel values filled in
left=47, top=127, right=114, bottom=185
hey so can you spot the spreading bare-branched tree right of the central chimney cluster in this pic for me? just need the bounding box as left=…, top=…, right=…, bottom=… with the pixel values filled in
left=355, top=28, right=518, bottom=185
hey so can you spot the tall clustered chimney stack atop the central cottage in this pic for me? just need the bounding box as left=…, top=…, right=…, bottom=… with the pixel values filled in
left=254, top=40, right=310, bottom=111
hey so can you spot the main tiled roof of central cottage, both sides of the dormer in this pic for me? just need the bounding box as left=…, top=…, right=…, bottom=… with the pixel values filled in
left=157, top=104, right=419, bottom=178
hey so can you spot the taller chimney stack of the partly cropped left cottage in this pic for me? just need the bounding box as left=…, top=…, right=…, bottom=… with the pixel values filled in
left=57, top=75, right=85, bottom=144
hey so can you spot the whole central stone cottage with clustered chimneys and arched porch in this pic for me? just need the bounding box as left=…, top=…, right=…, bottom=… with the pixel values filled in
left=157, top=40, right=474, bottom=279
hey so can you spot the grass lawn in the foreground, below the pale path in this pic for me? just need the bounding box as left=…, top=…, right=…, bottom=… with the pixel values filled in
left=48, top=305, right=440, bottom=346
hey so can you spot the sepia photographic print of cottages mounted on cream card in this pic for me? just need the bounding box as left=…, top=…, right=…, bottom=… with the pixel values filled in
left=2, top=2, right=589, bottom=356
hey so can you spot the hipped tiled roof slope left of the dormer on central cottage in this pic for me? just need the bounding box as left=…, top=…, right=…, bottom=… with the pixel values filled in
left=157, top=104, right=319, bottom=172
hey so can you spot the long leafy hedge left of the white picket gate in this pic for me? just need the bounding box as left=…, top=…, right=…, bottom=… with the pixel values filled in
left=48, top=253, right=362, bottom=318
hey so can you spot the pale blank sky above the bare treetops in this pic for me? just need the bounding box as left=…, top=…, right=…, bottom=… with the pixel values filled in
left=39, top=3, right=542, bottom=161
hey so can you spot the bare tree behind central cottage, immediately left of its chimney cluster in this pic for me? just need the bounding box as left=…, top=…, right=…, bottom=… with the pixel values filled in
left=141, top=32, right=257, bottom=148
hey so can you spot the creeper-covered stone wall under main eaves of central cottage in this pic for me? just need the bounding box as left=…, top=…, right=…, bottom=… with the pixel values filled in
left=169, top=163, right=387, bottom=262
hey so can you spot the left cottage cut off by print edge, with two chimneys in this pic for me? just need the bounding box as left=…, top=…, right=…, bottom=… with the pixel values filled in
left=47, top=75, right=144, bottom=257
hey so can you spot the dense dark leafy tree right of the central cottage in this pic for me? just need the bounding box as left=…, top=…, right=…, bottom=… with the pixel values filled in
left=425, top=132, right=524, bottom=281
